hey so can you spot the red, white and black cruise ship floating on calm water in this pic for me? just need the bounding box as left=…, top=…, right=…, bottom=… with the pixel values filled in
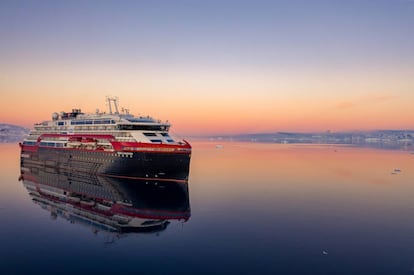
left=20, top=97, right=191, bottom=181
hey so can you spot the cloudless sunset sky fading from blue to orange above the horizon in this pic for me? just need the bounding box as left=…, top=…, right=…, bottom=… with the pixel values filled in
left=0, top=0, right=414, bottom=135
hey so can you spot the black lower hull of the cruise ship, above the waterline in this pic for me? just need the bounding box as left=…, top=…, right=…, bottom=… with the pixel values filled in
left=21, top=147, right=190, bottom=181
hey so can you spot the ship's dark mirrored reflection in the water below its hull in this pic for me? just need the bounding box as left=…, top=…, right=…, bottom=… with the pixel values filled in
left=20, top=163, right=191, bottom=236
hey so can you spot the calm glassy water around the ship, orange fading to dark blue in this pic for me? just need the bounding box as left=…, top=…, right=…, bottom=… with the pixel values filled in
left=0, top=142, right=414, bottom=274
